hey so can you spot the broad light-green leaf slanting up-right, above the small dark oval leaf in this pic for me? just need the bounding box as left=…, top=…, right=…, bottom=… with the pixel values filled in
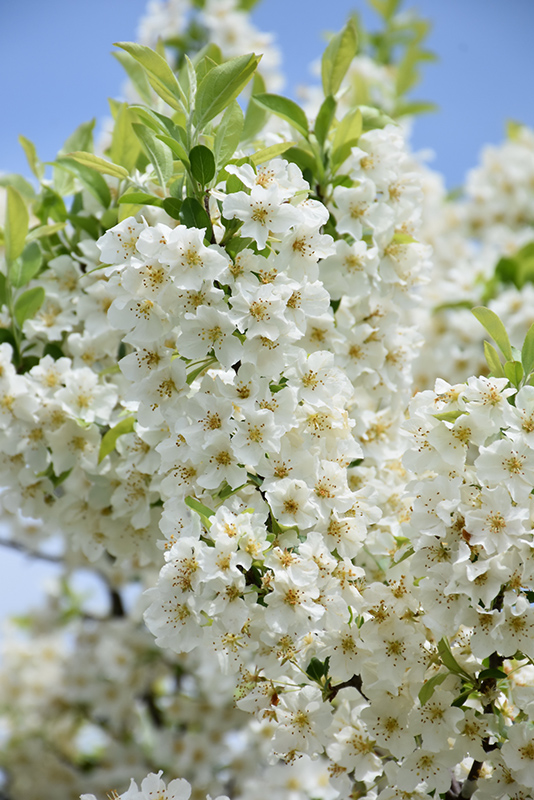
left=194, top=53, right=261, bottom=130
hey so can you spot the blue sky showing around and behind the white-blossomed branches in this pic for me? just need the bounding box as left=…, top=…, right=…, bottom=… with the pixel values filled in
left=0, top=0, right=534, bottom=617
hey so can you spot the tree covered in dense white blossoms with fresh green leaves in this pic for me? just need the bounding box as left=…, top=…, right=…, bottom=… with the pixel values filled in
left=0, top=0, right=534, bottom=800
